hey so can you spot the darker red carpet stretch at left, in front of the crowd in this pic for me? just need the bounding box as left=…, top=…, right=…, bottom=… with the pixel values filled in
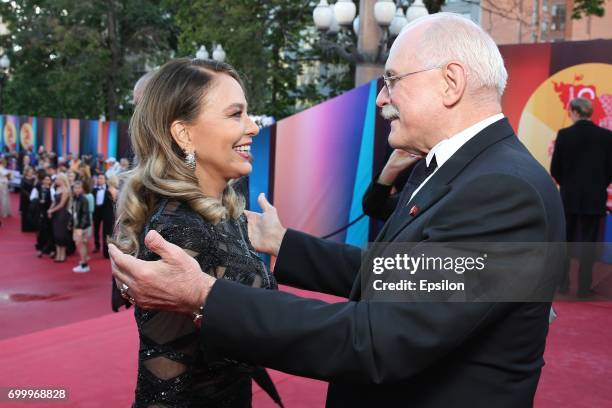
left=0, top=194, right=116, bottom=339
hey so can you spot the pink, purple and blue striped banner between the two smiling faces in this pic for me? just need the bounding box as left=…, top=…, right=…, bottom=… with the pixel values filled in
left=274, top=84, right=375, bottom=242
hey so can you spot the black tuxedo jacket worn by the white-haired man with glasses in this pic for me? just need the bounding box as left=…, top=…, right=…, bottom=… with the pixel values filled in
left=201, top=119, right=565, bottom=408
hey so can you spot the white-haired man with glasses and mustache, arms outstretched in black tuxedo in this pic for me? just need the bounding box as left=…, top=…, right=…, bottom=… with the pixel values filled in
left=112, top=13, right=564, bottom=408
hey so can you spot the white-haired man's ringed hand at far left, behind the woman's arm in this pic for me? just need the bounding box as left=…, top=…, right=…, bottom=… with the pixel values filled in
left=108, top=231, right=216, bottom=313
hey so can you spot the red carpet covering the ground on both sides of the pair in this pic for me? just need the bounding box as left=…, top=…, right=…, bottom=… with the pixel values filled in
left=0, top=194, right=612, bottom=408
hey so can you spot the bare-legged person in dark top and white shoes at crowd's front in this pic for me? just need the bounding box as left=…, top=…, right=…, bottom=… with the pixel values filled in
left=72, top=180, right=91, bottom=273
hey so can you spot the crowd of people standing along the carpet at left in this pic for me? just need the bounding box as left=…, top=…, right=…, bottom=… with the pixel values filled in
left=0, top=146, right=129, bottom=273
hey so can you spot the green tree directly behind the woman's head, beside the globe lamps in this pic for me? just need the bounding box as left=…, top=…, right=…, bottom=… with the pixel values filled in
left=167, top=0, right=352, bottom=119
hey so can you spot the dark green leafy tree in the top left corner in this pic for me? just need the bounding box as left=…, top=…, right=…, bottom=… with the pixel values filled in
left=0, top=0, right=173, bottom=120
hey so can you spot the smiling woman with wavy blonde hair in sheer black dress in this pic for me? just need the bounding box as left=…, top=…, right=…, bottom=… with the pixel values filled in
left=115, top=59, right=276, bottom=408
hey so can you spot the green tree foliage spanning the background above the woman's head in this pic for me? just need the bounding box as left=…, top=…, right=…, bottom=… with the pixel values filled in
left=0, top=0, right=605, bottom=119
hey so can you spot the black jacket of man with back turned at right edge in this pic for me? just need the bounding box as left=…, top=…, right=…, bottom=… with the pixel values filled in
left=550, top=120, right=612, bottom=215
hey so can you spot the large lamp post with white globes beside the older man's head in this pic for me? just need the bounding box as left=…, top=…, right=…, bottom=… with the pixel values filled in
left=312, top=0, right=429, bottom=86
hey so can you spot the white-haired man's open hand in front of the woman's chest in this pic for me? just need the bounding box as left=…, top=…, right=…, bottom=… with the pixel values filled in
left=245, top=193, right=287, bottom=256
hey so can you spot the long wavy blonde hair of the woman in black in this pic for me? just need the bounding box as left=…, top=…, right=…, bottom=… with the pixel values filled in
left=113, top=58, right=244, bottom=255
